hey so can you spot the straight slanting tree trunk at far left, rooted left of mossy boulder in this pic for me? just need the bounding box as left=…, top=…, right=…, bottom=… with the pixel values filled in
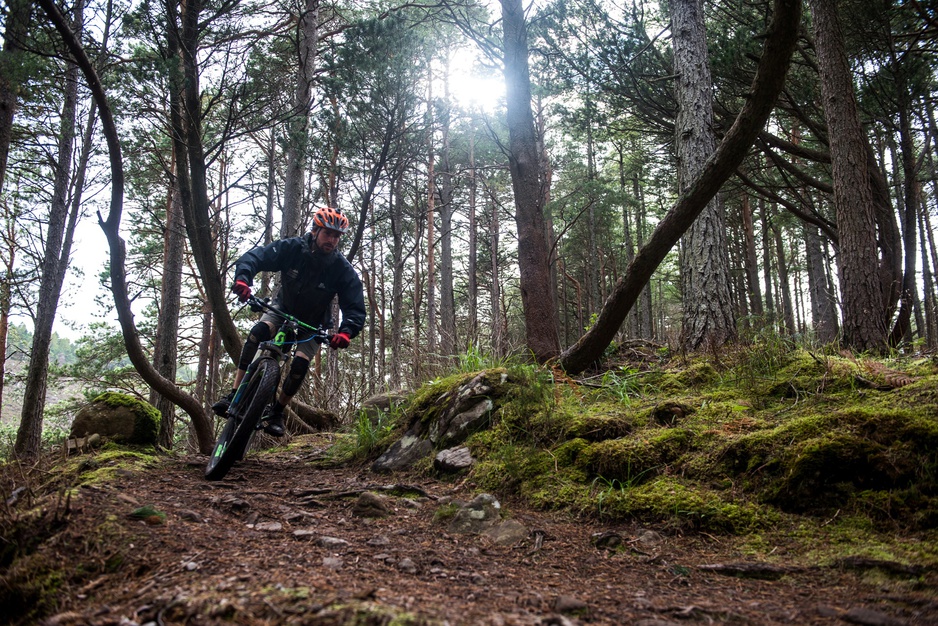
left=14, top=2, right=84, bottom=458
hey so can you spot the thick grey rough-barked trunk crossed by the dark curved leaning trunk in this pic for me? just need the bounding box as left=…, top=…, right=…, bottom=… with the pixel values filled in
left=671, top=0, right=736, bottom=350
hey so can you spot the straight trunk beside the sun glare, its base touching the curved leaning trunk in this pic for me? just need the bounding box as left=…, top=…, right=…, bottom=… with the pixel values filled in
left=500, top=0, right=560, bottom=363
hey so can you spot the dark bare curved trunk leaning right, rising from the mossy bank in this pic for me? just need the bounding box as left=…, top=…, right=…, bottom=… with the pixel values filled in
left=560, top=0, right=801, bottom=374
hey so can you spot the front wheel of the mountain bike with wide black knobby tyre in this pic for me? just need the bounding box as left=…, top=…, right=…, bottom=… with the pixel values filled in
left=205, top=358, right=280, bottom=480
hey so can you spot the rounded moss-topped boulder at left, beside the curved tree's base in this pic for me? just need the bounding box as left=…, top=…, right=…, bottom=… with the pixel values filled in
left=69, top=391, right=160, bottom=445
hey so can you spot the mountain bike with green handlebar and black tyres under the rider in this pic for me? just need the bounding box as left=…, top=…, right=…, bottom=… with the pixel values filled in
left=205, top=296, right=329, bottom=480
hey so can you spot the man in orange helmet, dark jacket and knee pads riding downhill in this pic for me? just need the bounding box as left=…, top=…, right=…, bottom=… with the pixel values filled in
left=212, top=207, right=365, bottom=437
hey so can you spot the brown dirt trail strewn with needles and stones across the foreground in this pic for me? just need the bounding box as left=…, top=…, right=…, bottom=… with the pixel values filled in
left=7, top=435, right=938, bottom=626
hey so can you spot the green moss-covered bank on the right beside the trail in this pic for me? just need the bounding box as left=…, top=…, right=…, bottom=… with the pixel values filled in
left=418, top=336, right=938, bottom=536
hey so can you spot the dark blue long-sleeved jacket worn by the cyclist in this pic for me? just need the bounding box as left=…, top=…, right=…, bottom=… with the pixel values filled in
left=235, top=233, right=365, bottom=337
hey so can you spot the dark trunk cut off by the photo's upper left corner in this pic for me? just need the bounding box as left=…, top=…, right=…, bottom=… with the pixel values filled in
left=0, top=0, right=33, bottom=191
